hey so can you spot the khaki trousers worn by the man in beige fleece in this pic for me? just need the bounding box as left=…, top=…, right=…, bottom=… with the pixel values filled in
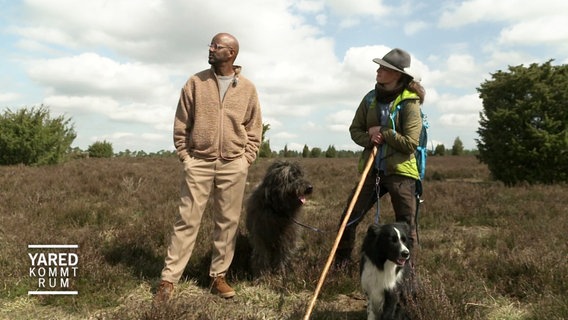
left=162, top=156, right=249, bottom=283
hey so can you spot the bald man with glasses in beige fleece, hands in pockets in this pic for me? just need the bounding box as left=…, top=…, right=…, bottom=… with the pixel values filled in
left=154, top=33, right=262, bottom=302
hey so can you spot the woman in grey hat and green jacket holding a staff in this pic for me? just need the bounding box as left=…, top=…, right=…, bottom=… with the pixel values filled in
left=335, top=48, right=425, bottom=266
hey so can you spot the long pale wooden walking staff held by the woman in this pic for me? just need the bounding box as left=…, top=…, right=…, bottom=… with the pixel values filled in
left=304, top=146, right=377, bottom=320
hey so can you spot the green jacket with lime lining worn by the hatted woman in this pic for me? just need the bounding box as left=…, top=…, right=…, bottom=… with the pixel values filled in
left=349, top=89, right=422, bottom=179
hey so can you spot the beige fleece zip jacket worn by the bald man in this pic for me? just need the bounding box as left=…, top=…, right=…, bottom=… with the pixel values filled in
left=174, top=69, right=262, bottom=164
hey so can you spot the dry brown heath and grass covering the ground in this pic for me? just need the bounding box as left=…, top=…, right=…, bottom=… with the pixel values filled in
left=0, top=157, right=568, bottom=320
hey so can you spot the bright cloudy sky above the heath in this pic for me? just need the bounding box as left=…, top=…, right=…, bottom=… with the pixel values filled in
left=0, top=0, right=568, bottom=152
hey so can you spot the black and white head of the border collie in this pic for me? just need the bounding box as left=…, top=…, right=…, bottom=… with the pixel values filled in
left=363, top=223, right=411, bottom=270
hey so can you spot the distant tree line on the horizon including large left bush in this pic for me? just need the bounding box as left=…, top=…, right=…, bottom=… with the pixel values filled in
left=0, top=105, right=470, bottom=165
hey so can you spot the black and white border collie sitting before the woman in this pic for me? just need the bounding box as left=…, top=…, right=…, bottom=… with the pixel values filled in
left=360, top=222, right=412, bottom=320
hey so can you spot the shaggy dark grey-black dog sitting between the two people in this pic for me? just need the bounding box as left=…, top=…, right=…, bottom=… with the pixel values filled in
left=246, top=161, right=313, bottom=275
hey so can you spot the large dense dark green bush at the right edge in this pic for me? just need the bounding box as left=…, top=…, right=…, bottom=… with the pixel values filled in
left=477, top=61, right=568, bottom=185
